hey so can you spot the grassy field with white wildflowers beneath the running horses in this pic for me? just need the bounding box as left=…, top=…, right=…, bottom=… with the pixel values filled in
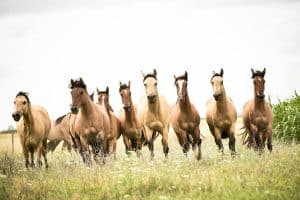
left=0, top=118, right=300, bottom=199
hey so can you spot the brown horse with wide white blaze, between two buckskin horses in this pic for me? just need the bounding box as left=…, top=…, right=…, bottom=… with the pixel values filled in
left=170, top=71, right=201, bottom=160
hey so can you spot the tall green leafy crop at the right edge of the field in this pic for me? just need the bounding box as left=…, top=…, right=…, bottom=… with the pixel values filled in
left=272, top=91, right=300, bottom=142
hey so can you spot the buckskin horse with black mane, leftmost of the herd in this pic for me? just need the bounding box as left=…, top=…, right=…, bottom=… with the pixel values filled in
left=12, top=91, right=51, bottom=168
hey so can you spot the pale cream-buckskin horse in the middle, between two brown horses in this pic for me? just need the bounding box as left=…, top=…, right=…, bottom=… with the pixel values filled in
left=138, top=69, right=170, bottom=158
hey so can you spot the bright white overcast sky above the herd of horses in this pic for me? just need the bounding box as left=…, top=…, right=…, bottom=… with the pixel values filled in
left=0, top=0, right=300, bottom=129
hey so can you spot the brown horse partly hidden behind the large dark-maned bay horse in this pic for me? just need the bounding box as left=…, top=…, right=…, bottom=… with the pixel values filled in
left=97, top=87, right=121, bottom=158
